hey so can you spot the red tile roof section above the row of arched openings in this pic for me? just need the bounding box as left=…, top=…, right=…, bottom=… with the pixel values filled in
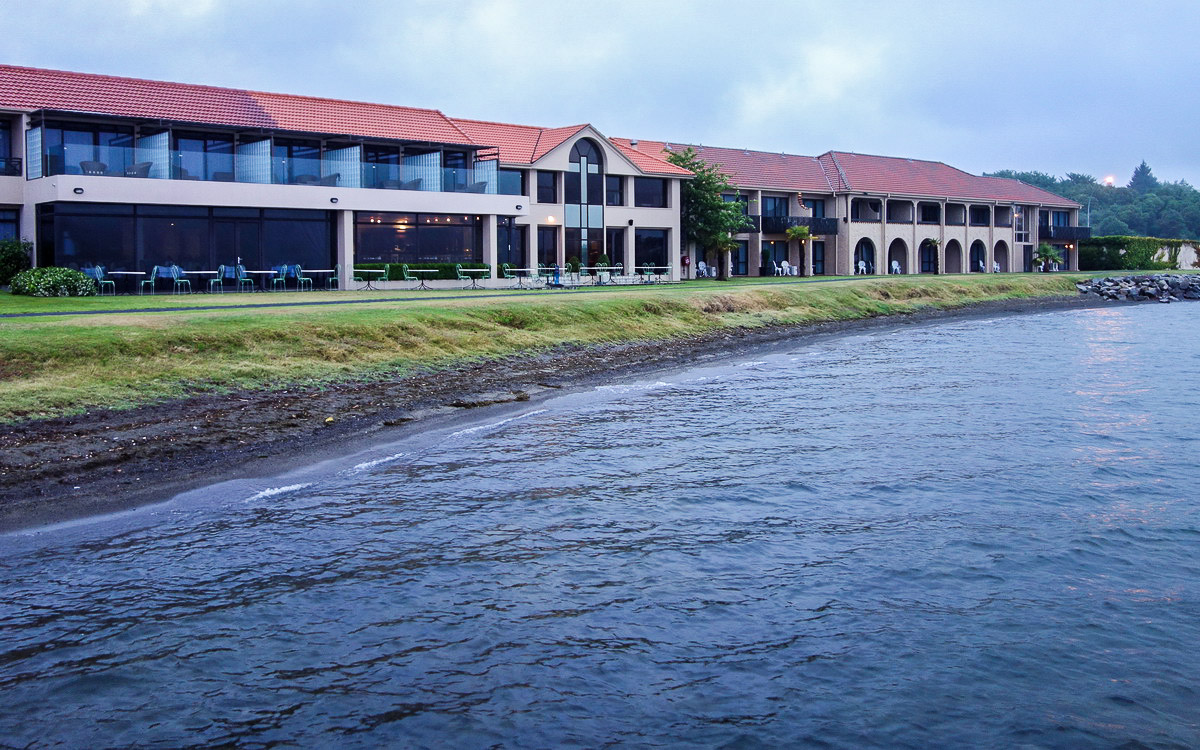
left=817, top=151, right=1079, bottom=208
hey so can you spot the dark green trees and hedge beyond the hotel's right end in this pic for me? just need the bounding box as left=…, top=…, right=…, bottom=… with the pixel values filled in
left=985, top=162, right=1200, bottom=239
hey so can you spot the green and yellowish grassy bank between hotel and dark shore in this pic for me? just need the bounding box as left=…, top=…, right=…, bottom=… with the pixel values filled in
left=0, top=275, right=1078, bottom=421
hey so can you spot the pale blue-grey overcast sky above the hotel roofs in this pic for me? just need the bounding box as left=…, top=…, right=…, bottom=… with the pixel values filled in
left=0, top=0, right=1200, bottom=185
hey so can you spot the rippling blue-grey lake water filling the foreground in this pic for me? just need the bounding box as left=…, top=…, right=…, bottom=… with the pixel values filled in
left=0, top=305, right=1200, bottom=748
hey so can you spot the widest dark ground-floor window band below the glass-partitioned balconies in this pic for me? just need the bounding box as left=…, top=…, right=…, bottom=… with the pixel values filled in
left=37, top=203, right=334, bottom=273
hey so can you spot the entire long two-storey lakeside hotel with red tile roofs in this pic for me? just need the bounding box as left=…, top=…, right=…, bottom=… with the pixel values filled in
left=0, top=65, right=1091, bottom=288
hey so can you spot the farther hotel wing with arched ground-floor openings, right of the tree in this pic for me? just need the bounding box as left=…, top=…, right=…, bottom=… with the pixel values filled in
left=618, top=140, right=1091, bottom=276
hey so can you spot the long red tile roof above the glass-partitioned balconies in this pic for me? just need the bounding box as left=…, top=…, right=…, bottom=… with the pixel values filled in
left=0, top=65, right=474, bottom=145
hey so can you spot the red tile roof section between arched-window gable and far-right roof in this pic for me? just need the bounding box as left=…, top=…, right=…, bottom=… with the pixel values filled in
left=613, top=138, right=833, bottom=193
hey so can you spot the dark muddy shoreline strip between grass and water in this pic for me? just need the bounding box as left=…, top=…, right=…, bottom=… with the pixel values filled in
left=0, top=289, right=1106, bottom=533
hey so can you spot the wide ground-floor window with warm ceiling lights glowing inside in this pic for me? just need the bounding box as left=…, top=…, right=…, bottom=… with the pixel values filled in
left=354, top=211, right=484, bottom=263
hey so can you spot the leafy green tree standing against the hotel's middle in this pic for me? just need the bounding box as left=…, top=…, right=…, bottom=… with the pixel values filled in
left=667, top=148, right=746, bottom=280
